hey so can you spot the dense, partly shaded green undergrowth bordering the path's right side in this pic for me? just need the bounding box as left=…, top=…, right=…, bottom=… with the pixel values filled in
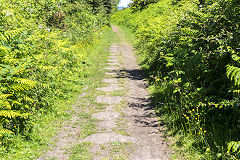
left=112, top=0, right=240, bottom=159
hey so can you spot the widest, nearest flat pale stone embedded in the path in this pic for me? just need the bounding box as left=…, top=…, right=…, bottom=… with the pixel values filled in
left=84, top=133, right=137, bottom=144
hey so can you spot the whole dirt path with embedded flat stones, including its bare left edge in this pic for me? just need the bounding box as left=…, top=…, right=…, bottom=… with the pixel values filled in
left=36, top=26, right=171, bottom=160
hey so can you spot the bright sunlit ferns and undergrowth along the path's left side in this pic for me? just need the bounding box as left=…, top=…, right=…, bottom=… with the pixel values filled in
left=0, top=0, right=117, bottom=158
